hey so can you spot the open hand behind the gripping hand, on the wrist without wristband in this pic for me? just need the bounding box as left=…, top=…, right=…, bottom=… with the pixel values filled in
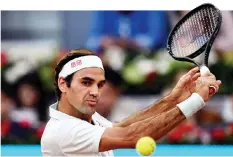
left=170, top=67, right=201, bottom=104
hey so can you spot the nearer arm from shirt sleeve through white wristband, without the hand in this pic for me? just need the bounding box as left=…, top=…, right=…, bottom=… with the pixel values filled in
left=100, top=93, right=205, bottom=151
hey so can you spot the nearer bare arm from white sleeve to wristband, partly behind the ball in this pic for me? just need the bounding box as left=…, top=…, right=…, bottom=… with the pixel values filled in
left=99, top=107, right=185, bottom=152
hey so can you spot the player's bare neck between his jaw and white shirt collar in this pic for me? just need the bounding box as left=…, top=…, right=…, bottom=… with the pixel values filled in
left=57, top=97, right=91, bottom=123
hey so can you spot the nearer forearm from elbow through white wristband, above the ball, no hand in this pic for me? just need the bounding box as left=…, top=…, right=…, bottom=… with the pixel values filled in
left=126, top=93, right=205, bottom=145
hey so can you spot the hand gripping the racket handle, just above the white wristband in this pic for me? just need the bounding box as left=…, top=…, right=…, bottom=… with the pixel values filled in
left=195, top=73, right=221, bottom=102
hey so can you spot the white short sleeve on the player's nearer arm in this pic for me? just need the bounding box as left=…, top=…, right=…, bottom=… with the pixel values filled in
left=60, top=122, right=106, bottom=156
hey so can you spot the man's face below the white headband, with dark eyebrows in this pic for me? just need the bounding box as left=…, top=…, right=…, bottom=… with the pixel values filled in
left=65, top=68, right=105, bottom=115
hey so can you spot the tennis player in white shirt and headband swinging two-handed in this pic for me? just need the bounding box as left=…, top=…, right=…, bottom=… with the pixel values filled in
left=41, top=49, right=221, bottom=156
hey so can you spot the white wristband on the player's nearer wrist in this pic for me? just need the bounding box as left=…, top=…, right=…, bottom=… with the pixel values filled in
left=176, top=93, right=205, bottom=118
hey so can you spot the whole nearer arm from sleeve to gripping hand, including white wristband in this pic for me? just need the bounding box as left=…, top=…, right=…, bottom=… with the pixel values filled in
left=99, top=70, right=221, bottom=152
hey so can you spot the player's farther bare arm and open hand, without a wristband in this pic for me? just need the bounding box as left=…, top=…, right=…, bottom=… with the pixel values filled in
left=113, top=68, right=200, bottom=127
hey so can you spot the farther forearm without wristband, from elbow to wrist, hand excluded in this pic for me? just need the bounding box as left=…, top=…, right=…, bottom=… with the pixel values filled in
left=115, top=96, right=176, bottom=127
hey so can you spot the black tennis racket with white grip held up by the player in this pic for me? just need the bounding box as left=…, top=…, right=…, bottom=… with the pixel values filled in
left=167, top=3, right=222, bottom=93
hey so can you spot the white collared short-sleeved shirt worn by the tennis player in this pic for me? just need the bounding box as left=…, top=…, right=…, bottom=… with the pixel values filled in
left=41, top=103, right=114, bottom=156
